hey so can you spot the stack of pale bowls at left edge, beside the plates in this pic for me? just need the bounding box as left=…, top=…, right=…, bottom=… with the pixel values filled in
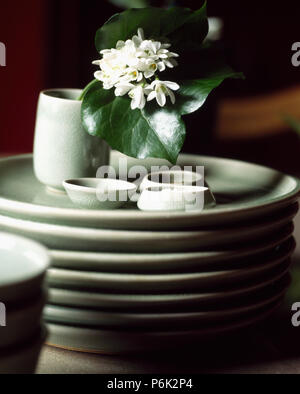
left=0, top=233, right=50, bottom=374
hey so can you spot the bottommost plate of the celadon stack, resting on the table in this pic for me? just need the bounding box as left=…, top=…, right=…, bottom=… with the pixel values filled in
left=47, top=301, right=281, bottom=354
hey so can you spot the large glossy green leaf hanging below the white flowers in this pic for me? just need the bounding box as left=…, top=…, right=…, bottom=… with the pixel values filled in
left=82, top=84, right=185, bottom=163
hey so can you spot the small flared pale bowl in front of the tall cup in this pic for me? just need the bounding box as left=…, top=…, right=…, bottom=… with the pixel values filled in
left=63, top=178, right=137, bottom=209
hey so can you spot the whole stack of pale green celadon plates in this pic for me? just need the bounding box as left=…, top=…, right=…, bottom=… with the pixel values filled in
left=0, top=152, right=300, bottom=354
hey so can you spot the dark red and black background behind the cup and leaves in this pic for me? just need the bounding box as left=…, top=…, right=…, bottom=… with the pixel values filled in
left=0, top=0, right=300, bottom=173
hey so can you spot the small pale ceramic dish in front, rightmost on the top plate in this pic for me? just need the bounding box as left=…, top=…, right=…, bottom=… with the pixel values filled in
left=138, top=185, right=216, bottom=211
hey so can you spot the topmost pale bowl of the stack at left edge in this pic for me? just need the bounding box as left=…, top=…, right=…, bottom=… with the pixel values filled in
left=0, top=233, right=50, bottom=304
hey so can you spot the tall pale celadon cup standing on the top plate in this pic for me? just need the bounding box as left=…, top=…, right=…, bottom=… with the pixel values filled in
left=34, top=89, right=110, bottom=192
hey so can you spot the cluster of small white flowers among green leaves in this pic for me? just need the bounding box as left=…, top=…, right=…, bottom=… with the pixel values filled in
left=93, top=28, right=179, bottom=109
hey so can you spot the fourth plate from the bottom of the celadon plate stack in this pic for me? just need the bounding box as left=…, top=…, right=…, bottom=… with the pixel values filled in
left=47, top=239, right=295, bottom=294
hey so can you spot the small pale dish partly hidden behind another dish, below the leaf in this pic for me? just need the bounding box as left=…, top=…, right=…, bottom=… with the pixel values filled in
left=140, top=170, right=207, bottom=191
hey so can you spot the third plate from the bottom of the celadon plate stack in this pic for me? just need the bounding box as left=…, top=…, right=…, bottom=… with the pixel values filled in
left=48, top=266, right=289, bottom=312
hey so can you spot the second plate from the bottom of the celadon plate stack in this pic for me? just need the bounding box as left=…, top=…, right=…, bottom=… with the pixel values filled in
left=44, top=281, right=289, bottom=330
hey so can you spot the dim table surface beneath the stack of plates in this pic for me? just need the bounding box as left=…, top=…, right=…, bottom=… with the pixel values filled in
left=37, top=208, right=300, bottom=374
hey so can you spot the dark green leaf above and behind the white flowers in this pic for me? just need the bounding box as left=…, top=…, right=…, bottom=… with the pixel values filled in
left=95, top=4, right=208, bottom=52
